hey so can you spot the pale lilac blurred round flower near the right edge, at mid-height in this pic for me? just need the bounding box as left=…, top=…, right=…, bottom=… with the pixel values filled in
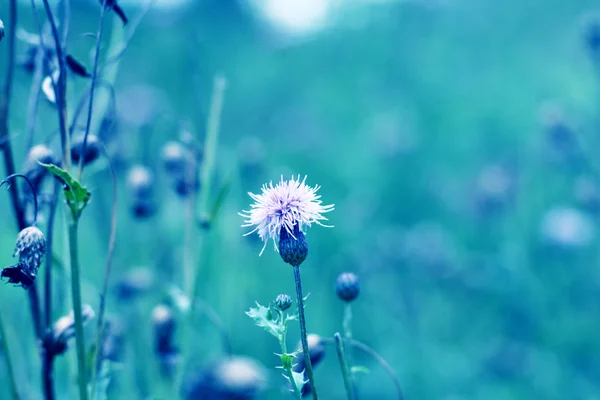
left=541, top=207, right=595, bottom=250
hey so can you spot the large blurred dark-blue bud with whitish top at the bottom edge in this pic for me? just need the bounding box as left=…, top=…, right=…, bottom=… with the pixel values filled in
left=182, top=356, right=267, bottom=400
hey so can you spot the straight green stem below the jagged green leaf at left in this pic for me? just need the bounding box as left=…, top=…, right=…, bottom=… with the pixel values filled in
left=69, top=219, right=88, bottom=400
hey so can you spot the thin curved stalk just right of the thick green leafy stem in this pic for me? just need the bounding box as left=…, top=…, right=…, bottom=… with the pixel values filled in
left=91, top=147, right=117, bottom=399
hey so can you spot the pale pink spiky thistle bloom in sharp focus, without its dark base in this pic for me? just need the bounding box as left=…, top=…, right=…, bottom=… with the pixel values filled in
left=240, top=175, right=334, bottom=254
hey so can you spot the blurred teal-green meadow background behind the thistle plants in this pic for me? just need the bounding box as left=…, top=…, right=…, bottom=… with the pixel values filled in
left=0, top=0, right=600, bottom=400
